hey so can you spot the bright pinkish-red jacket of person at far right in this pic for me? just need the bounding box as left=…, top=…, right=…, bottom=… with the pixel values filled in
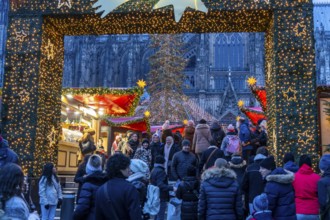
left=292, top=164, right=321, bottom=215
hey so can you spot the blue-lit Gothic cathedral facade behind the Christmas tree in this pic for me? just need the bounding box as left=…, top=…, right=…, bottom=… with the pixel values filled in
left=0, top=0, right=330, bottom=123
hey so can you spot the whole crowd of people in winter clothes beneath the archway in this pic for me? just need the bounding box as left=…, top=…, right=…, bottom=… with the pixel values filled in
left=0, top=118, right=330, bottom=220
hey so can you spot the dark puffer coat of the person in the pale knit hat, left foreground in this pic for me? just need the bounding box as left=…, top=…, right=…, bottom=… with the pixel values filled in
left=73, top=171, right=107, bottom=220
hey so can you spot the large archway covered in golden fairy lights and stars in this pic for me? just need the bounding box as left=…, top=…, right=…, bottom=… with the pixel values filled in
left=2, top=0, right=318, bottom=173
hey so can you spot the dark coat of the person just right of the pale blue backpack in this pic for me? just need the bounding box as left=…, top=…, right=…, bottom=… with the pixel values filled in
left=150, top=164, right=173, bottom=201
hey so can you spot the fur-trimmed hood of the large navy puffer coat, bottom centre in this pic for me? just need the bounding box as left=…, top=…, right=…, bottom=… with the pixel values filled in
left=202, top=167, right=236, bottom=188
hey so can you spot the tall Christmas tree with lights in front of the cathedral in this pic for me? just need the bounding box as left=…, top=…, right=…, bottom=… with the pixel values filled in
left=148, top=35, right=188, bottom=124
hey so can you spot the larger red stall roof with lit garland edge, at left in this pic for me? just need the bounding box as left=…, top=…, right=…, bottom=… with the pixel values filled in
left=62, top=87, right=143, bottom=117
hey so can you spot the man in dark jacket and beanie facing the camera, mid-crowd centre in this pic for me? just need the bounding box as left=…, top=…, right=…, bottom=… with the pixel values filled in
left=171, top=139, right=197, bottom=181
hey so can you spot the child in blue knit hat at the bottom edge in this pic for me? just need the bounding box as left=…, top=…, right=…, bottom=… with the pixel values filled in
left=246, top=193, right=273, bottom=220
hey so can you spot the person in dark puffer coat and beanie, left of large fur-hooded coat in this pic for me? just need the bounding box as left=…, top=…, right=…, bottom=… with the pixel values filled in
left=176, top=166, right=199, bottom=220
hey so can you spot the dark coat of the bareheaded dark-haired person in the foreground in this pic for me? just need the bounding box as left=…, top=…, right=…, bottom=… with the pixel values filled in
left=95, top=178, right=142, bottom=220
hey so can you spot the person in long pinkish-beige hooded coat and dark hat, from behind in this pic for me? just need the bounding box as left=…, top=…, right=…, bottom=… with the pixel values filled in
left=192, top=119, right=212, bottom=160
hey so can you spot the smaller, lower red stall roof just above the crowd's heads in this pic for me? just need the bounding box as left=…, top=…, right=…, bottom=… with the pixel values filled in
left=101, top=117, right=150, bottom=132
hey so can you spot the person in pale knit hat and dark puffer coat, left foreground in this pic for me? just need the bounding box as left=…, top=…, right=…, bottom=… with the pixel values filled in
left=73, top=154, right=108, bottom=220
